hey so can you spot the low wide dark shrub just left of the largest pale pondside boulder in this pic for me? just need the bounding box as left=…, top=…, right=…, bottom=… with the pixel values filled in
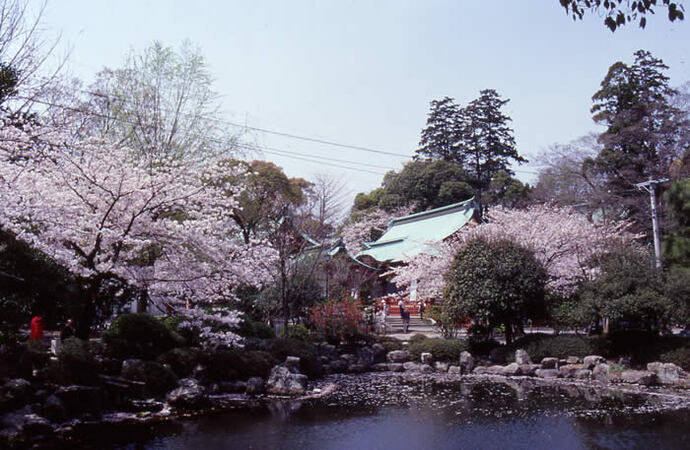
left=206, top=348, right=278, bottom=381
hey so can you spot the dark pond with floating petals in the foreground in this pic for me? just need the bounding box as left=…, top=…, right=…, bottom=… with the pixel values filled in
left=98, top=374, right=690, bottom=450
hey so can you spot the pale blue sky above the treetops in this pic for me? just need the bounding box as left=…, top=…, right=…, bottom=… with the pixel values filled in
left=36, top=0, right=690, bottom=204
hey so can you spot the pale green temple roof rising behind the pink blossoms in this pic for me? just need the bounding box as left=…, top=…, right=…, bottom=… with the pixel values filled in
left=355, top=197, right=479, bottom=262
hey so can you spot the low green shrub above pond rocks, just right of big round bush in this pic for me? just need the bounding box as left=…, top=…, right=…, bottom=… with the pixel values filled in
left=509, top=334, right=596, bottom=362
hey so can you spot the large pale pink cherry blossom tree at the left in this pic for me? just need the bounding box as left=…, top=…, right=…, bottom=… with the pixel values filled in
left=0, top=121, right=275, bottom=343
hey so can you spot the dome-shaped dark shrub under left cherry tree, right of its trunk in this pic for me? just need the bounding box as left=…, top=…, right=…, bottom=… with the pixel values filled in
left=103, top=313, right=185, bottom=359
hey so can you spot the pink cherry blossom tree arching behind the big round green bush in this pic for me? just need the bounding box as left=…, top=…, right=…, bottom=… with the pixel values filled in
left=384, top=205, right=639, bottom=297
